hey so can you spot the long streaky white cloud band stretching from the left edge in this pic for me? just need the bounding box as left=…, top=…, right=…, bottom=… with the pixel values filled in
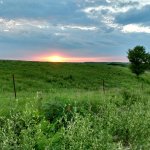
left=0, top=18, right=98, bottom=37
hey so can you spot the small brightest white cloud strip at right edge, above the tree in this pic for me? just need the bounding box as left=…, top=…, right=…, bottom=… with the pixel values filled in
left=122, top=24, right=150, bottom=33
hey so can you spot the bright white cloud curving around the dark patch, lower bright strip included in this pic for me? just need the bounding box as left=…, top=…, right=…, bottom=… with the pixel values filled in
left=81, top=0, right=150, bottom=33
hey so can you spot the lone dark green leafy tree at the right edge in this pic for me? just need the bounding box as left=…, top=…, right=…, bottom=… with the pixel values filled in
left=128, top=46, right=150, bottom=77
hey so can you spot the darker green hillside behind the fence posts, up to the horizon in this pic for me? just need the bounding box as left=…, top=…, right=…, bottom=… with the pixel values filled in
left=0, top=61, right=150, bottom=92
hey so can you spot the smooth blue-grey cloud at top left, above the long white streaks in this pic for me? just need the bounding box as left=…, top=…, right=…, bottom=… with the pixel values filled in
left=0, top=0, right=94, bottom=24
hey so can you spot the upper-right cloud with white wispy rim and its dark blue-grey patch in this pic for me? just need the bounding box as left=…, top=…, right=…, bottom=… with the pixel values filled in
left=82, top=0, right=150, bottom=31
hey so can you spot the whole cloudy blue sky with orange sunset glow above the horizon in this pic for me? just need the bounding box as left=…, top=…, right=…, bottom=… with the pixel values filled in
left=0, top=0, right=150, bottom=62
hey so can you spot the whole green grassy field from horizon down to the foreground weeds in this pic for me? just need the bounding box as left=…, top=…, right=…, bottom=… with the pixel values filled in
left=0, top=61, right=150, bottom=150
